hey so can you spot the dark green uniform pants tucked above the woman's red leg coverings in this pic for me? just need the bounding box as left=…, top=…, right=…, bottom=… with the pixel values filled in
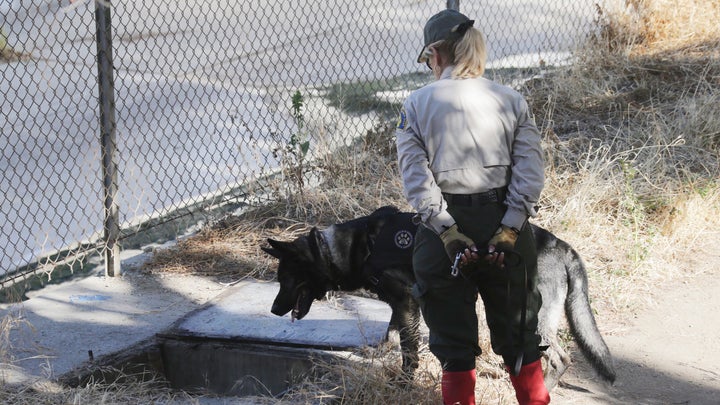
left=413, top=203, right=542, bottom=371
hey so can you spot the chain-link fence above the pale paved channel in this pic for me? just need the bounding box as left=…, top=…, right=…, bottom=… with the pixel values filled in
left=0, top=0, right=596, bottom=289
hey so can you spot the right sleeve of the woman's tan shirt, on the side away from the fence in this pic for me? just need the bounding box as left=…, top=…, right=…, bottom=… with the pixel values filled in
left=501, top=98, right=545, bottom=229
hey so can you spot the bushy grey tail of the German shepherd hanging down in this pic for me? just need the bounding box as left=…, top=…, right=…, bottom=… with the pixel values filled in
left=565, top=249, right=616, bottom=383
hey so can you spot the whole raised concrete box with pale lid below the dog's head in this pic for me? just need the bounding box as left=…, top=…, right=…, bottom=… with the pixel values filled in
left=158, top=281, right=391, bottom=396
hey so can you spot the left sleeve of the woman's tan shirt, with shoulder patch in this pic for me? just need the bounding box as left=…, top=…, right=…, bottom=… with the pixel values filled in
left=395, top=99, right=455, bottom=234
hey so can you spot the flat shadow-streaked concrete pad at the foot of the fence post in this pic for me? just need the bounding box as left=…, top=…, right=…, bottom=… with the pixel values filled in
left=0, top=252, right=227, bottom=384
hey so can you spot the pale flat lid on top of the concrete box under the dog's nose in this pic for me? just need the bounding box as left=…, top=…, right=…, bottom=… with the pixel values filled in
left=170, top=281, right=391, bottom=350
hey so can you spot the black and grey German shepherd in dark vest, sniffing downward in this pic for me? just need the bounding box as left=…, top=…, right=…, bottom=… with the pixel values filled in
left=262, top=206, right=615, bottom=389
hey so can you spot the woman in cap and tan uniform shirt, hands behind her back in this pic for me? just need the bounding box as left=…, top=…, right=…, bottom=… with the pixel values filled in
left=396, top=9, right=550, bottom=405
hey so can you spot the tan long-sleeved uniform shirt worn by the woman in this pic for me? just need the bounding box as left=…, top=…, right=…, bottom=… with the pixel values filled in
left=396, top=66, right=545, bottom=233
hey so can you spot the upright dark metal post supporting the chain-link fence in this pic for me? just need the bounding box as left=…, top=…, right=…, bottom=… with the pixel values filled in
left=95, top=0, right=120, bottom=277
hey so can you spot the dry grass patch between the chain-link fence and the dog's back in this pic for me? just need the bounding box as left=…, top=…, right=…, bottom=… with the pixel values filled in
left=145, top=120, right=408, bottom=281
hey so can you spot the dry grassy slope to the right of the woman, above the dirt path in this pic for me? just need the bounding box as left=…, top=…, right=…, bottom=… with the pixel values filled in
left=525, top=0, right=720, bottom=312
